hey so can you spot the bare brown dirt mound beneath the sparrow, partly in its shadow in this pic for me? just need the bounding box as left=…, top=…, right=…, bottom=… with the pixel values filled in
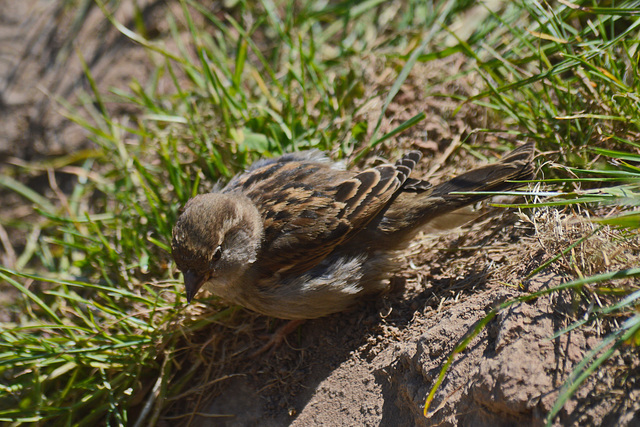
left=186, top=214, right=640, bottom=426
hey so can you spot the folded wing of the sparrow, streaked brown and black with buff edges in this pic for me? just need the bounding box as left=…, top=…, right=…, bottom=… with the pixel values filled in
left=223, top=151, right=421, bottom=275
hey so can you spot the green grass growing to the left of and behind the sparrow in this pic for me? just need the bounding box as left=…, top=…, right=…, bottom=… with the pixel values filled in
left=0, top=1, right=476, bottom=425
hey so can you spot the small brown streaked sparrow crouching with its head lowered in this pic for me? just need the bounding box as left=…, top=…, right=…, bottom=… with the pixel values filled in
left=171, top=143, right=534, bottom=319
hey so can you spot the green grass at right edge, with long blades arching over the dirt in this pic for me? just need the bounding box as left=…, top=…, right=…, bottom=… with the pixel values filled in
left=425, top=1, right=640, bottom=425
